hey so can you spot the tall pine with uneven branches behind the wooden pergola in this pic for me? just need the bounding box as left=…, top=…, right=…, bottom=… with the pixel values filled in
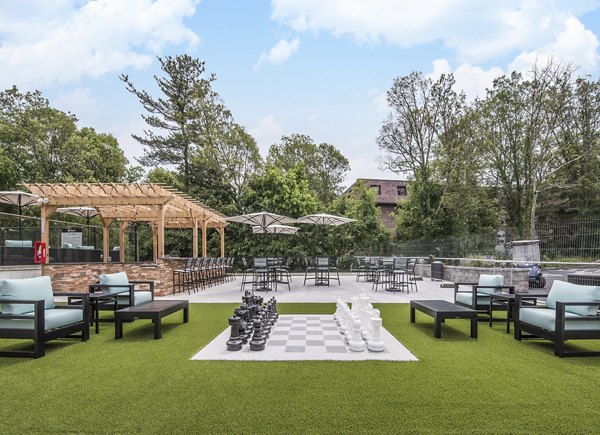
left=121, top=55, right=231, bottom=192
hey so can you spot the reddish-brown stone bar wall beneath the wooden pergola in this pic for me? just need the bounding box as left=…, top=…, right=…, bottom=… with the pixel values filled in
left=42, top=258, right=185, bottom=296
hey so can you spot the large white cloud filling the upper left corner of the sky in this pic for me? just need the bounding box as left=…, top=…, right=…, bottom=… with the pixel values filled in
left=0, top=0, right=199, bottom=88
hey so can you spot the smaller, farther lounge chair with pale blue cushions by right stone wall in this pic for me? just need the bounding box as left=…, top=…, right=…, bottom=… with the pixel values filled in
left=454, top=274, right=515, bottom=316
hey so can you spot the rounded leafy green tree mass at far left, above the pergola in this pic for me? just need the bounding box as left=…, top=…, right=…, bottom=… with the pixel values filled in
left=0, top=87, right=127, bottom=187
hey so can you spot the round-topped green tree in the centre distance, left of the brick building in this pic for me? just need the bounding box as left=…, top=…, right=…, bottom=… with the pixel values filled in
left=267, top=134, right=350, bottom=206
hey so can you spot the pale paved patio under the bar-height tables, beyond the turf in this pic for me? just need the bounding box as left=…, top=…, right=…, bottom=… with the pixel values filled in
left=157, top=274, right=454, bottom=303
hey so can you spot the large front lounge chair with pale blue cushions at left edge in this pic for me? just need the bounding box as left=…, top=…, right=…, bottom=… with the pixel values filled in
left=0, top=276, right=90, bottom=358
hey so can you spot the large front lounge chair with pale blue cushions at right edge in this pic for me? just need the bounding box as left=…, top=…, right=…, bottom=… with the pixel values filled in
left=515, top=280, right=600, bottom=358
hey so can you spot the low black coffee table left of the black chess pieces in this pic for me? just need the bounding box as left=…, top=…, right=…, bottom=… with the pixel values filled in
left=115, top=301, right=189, bottom=340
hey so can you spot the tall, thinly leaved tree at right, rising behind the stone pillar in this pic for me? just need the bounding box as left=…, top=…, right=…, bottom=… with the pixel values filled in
left=478, top=62, right=585, bottom=237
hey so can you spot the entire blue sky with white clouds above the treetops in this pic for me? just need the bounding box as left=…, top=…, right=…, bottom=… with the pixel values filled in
left=0, top=0, right=600, bottom=184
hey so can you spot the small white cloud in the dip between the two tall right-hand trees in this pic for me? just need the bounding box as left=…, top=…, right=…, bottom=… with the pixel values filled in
left=428, top=59, right=504, bottom=101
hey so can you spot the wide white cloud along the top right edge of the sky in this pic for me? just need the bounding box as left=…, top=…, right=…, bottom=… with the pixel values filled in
left=271, top=0, right=597, bottom=63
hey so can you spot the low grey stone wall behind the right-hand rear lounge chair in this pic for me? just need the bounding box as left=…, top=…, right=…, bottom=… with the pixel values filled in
left=415, top=264, right=529, bottom=292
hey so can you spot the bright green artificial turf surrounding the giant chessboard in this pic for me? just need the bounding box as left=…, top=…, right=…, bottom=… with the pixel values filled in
left=0, top=304, right=600, bottom=434
